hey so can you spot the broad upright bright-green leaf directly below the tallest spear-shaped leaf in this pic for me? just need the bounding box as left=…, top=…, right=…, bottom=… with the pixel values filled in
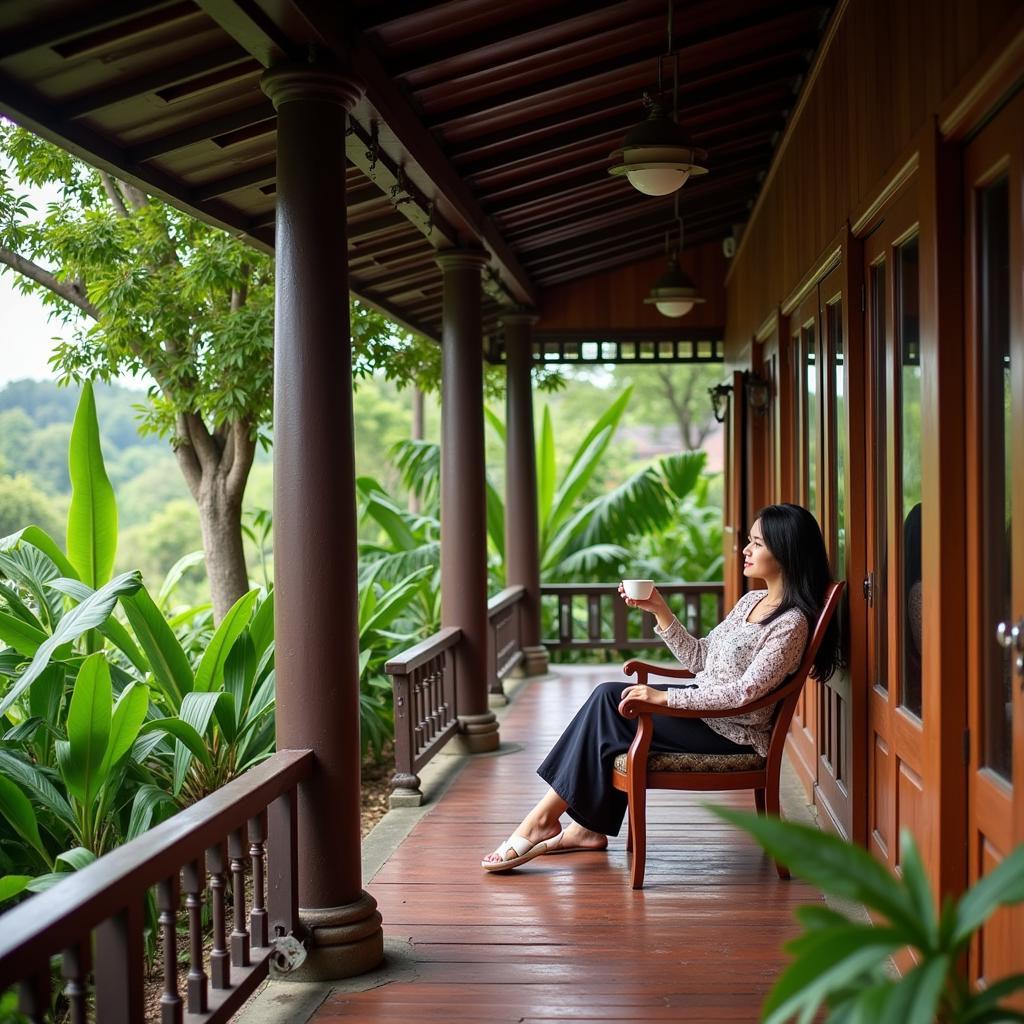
left=65, top=652, right=114, bottom=807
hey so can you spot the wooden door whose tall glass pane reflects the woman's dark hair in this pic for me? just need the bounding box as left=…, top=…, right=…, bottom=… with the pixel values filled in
left=863, top=180, right=928, bottom=868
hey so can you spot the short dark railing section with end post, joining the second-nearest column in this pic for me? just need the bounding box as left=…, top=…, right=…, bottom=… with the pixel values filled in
left=384, top=627, right=462, bottom=807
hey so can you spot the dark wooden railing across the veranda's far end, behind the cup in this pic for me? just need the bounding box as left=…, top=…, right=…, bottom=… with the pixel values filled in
left=541, top=583, right=724, bottom=651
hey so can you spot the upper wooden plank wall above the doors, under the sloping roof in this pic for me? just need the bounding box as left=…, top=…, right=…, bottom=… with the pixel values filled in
left=726, top=0, right=1024, bottom=366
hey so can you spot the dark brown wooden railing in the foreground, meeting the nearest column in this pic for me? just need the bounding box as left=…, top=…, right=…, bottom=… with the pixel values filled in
left=0, top=751, right=313, bottom=1024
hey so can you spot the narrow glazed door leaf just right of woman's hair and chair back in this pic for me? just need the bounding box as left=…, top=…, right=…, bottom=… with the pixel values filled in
left=815, top=263, right=853, bottom=839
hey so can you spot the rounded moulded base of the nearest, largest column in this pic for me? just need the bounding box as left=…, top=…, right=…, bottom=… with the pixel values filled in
left=281, top=892, right=384, bottom=981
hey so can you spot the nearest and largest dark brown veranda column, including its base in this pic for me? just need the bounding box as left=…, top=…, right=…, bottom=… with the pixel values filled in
left=261, top=65, right=383, bottom=981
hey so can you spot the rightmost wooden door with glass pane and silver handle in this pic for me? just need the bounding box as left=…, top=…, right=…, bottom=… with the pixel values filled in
left=964, top=93, right=1024, bottom=983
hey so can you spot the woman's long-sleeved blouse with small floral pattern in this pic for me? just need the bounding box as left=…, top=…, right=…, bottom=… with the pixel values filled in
left=654, top=590, right=808, bottom=757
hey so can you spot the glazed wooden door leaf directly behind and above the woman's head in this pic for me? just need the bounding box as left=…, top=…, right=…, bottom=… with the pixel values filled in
left=788, top=287, right=821, bottom=800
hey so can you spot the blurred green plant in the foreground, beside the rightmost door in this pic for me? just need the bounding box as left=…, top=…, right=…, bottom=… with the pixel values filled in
left=713, top=807, right=1024, bottom=1024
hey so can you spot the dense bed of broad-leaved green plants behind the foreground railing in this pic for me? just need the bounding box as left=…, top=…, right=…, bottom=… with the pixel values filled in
left=0, top=384, right=273, bottom=898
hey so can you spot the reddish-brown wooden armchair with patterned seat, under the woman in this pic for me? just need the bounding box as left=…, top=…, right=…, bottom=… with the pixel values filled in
left=611, top=583, right=844, bottom=889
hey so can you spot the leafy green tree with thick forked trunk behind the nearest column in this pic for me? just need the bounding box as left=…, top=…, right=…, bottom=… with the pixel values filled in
left=0, top=130, right=439, bottom=620
